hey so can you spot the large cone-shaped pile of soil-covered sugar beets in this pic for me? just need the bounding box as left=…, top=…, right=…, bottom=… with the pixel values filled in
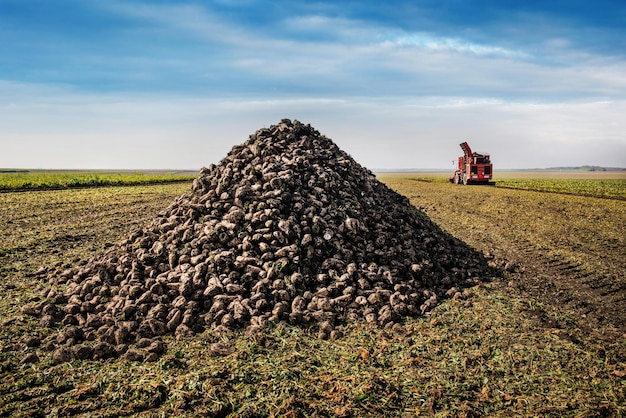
left=23, top=119, right=489, bottom=361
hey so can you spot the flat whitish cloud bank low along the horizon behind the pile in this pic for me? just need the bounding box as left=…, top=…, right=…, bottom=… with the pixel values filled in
left=0, top=83, right=626, bottom=169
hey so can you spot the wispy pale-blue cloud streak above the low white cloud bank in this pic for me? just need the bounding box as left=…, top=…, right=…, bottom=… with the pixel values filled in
left=89, top=2, right=626, bottom=101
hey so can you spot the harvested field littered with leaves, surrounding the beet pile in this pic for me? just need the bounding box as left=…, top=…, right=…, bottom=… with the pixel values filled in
left=0, top=173, right=626, bottom=417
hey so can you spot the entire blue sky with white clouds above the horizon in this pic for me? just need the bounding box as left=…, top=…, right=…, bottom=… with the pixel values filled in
left=0, top=0, right=626, bottom=171
